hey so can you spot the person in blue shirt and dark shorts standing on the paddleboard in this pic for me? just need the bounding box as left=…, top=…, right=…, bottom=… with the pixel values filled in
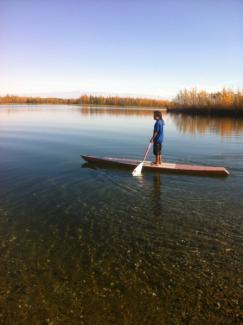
left=150, top=111, right=165, bottom=166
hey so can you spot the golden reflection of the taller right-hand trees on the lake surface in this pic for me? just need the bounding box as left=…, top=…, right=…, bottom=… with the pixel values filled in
left=171, top=114, right=243, bottom=136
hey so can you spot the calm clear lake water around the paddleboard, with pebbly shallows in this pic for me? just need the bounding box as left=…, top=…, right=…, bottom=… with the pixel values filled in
left=0, top=106, right=243, bottom=324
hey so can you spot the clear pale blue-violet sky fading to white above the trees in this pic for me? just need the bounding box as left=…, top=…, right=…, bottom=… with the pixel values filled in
left=0, top=0, right=243, bottom=98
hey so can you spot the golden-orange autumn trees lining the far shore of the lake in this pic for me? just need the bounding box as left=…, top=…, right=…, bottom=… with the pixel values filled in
left=0, top=88, right=243, bottom=114
